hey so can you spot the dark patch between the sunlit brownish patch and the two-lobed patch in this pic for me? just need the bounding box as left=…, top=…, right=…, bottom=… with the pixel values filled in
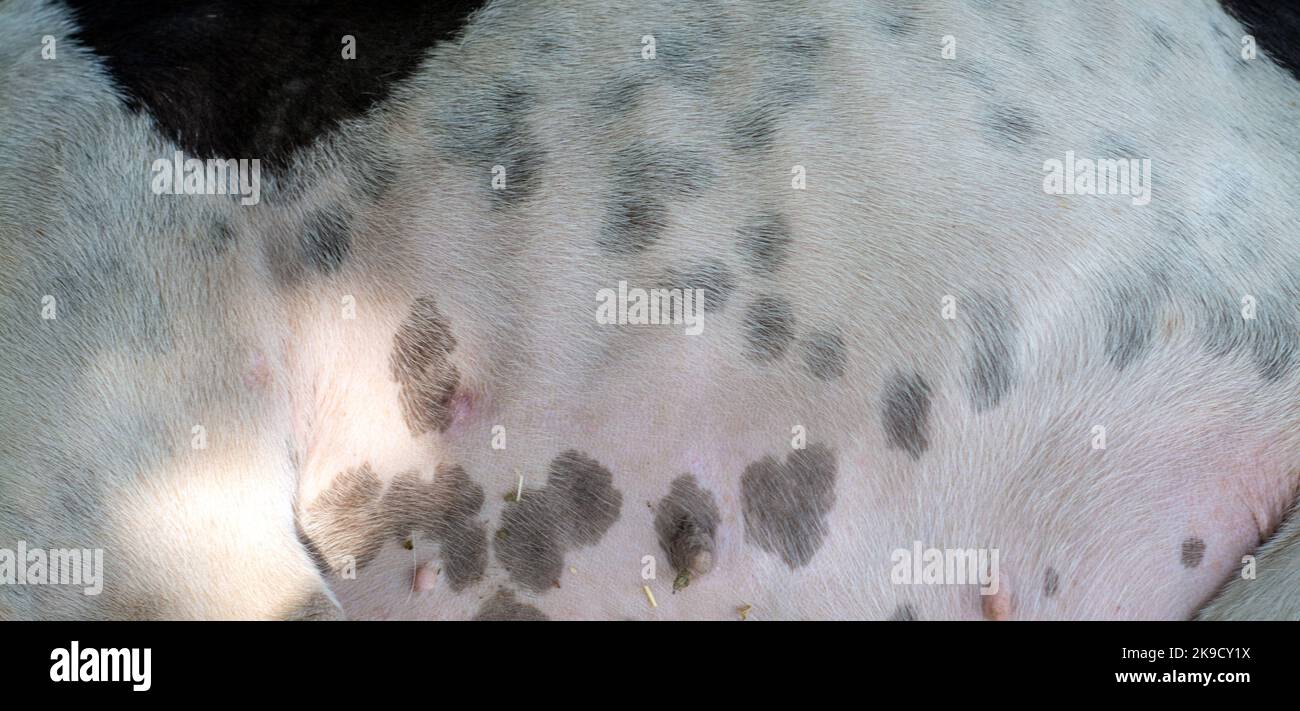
left=381, top=465, right=488, bottom=591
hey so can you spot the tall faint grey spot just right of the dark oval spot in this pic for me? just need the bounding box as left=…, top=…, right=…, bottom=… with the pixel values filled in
left=967, top=291, right=1018, bottom=412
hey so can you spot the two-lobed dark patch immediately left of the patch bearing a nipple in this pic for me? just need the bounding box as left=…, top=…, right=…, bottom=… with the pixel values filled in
left=494, top=450, right=623, bottom=593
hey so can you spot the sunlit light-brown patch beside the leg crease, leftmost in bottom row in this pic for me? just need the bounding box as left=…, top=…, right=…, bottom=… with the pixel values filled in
left=300, top=464, right=384, bottom=573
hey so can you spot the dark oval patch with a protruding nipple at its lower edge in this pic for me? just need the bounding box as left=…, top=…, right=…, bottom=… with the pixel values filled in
left=654, top=474, right=722, bottom=576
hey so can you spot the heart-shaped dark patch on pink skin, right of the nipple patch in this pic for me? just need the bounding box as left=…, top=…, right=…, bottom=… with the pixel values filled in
left=741, top=445, right=836, bottom=569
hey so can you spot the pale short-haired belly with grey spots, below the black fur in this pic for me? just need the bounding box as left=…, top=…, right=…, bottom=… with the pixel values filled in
left=0, top=0, right=1300, bottom=620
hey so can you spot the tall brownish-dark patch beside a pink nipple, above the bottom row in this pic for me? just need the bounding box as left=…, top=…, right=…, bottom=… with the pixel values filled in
left=389, top=296, right=460, bottom=435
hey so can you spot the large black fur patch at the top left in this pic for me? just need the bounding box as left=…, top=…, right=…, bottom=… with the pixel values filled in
left=66, top=0, right=485, bottom=169
